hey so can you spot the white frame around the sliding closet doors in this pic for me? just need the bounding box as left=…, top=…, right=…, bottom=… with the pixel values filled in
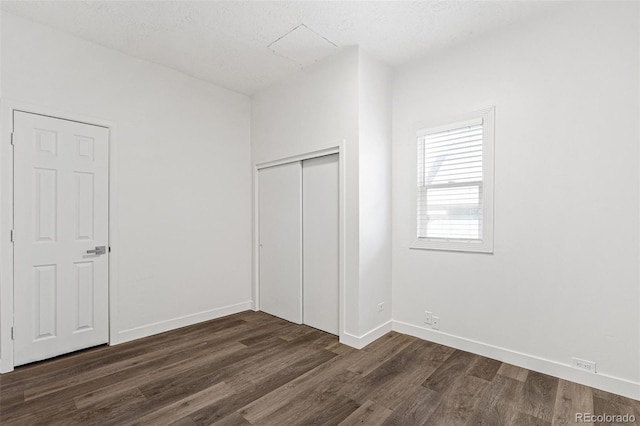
left=252, top=140, right=346, bottom=338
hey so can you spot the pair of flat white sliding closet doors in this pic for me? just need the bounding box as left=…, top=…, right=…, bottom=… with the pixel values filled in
left=258, top=154, right=340, bottom=335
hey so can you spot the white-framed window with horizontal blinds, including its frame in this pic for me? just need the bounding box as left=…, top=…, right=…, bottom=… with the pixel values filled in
left=412, top=108, right=493, bottom=253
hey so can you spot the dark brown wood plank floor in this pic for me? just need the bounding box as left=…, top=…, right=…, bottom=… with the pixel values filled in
left=0, top=311, right=640, bottom=426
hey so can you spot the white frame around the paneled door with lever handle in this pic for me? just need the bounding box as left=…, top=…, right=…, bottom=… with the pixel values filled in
left=0, top=99, right=118, bottom=373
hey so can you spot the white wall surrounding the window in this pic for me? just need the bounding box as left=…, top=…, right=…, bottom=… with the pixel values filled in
left=392, top=2, right=640, bottom=398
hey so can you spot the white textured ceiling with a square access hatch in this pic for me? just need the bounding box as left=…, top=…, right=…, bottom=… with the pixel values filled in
left=2, top=0, right=559, bottom=95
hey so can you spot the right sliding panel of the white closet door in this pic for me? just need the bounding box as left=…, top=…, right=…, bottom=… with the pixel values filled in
left=302, top=154, right=340, bottom=334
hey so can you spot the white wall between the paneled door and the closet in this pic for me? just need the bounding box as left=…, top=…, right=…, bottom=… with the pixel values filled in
left=1, top=13, right=252, bottom=356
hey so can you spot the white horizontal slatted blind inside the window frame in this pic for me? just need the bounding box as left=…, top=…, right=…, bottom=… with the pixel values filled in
left=417, top=119, right=483, bottom=240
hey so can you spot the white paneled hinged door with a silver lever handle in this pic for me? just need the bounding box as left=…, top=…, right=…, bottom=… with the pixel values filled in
left=13, top=111, right=109, bottom=365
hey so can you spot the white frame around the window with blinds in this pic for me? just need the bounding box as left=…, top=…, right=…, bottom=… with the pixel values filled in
left=409, top=107, right=495, bottom=253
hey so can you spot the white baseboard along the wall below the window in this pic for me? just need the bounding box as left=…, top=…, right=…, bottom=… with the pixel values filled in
left=392, top=321, right=640, bottom=400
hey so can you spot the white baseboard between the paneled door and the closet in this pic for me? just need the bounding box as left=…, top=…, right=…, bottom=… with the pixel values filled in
left=114, top=301, right=253, bottom=345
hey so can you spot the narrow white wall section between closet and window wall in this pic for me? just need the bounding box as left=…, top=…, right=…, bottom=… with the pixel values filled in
left=358, top=50, right=392, bottom=335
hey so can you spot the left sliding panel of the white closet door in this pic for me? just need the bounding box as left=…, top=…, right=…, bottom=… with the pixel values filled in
left=258, top=162, right=302, bottom=324
